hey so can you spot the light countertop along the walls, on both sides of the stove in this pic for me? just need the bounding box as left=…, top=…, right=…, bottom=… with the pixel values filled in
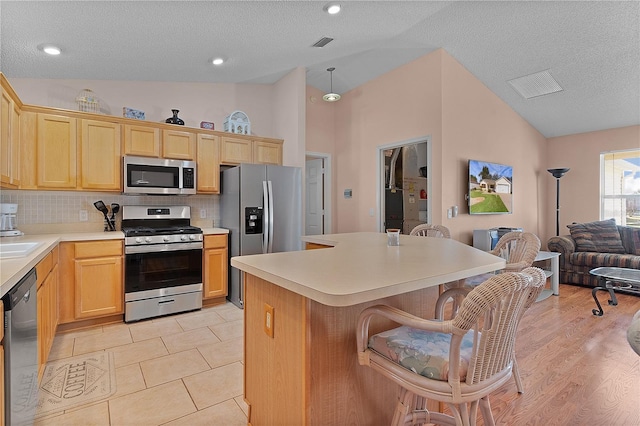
left=0, top=228, right=229, bottom=297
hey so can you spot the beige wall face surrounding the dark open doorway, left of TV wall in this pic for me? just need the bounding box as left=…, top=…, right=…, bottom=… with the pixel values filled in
left=334, top=52, right=442, bottom=232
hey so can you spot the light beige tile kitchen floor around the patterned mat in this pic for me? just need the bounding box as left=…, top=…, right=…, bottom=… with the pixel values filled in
left=35, top=303, right=247, bottom=426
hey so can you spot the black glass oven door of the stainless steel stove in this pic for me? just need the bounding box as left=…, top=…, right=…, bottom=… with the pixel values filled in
left=124, top=243, right=202, bottom=294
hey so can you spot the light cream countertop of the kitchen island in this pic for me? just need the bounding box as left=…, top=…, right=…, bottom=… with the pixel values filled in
left=231, top=232, right=505, bottom=306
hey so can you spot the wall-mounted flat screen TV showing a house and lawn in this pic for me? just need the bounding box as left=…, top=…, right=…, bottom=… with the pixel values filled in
left=467, top=160, right=513, bottom=214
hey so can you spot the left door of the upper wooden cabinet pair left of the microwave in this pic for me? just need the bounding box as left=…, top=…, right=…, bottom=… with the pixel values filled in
left=37, top=114, right=77, bottom=189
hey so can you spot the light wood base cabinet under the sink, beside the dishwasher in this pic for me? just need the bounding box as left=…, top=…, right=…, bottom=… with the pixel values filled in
left=36, top=247, right=58, bottom=378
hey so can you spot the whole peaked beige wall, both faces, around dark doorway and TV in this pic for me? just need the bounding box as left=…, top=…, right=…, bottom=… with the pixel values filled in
left=320, top=50, right=546, bottom=243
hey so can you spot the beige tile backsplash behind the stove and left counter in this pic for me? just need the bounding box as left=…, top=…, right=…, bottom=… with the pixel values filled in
left=0, top=190, right=220, bottom=233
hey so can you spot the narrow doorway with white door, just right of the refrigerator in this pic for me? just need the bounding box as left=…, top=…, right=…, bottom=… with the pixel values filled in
left=304, top=152, right=331, bottom=235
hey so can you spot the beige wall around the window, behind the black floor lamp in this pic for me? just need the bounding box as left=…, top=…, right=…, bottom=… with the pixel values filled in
left=545, top=126, right=640, bottom=243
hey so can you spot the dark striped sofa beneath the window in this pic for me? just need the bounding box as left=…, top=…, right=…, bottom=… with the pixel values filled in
left=547, top=219, right=640, bottom=295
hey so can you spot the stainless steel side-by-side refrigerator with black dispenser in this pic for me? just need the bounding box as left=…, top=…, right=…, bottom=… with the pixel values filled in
left=220, top=164, right=302, bottom=307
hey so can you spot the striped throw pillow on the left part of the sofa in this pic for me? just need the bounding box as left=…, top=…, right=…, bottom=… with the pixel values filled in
left=567, top=219, right=625, bottom=253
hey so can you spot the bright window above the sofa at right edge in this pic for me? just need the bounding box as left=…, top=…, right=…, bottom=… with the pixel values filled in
left=600, top=149, right=640, bottom=228
